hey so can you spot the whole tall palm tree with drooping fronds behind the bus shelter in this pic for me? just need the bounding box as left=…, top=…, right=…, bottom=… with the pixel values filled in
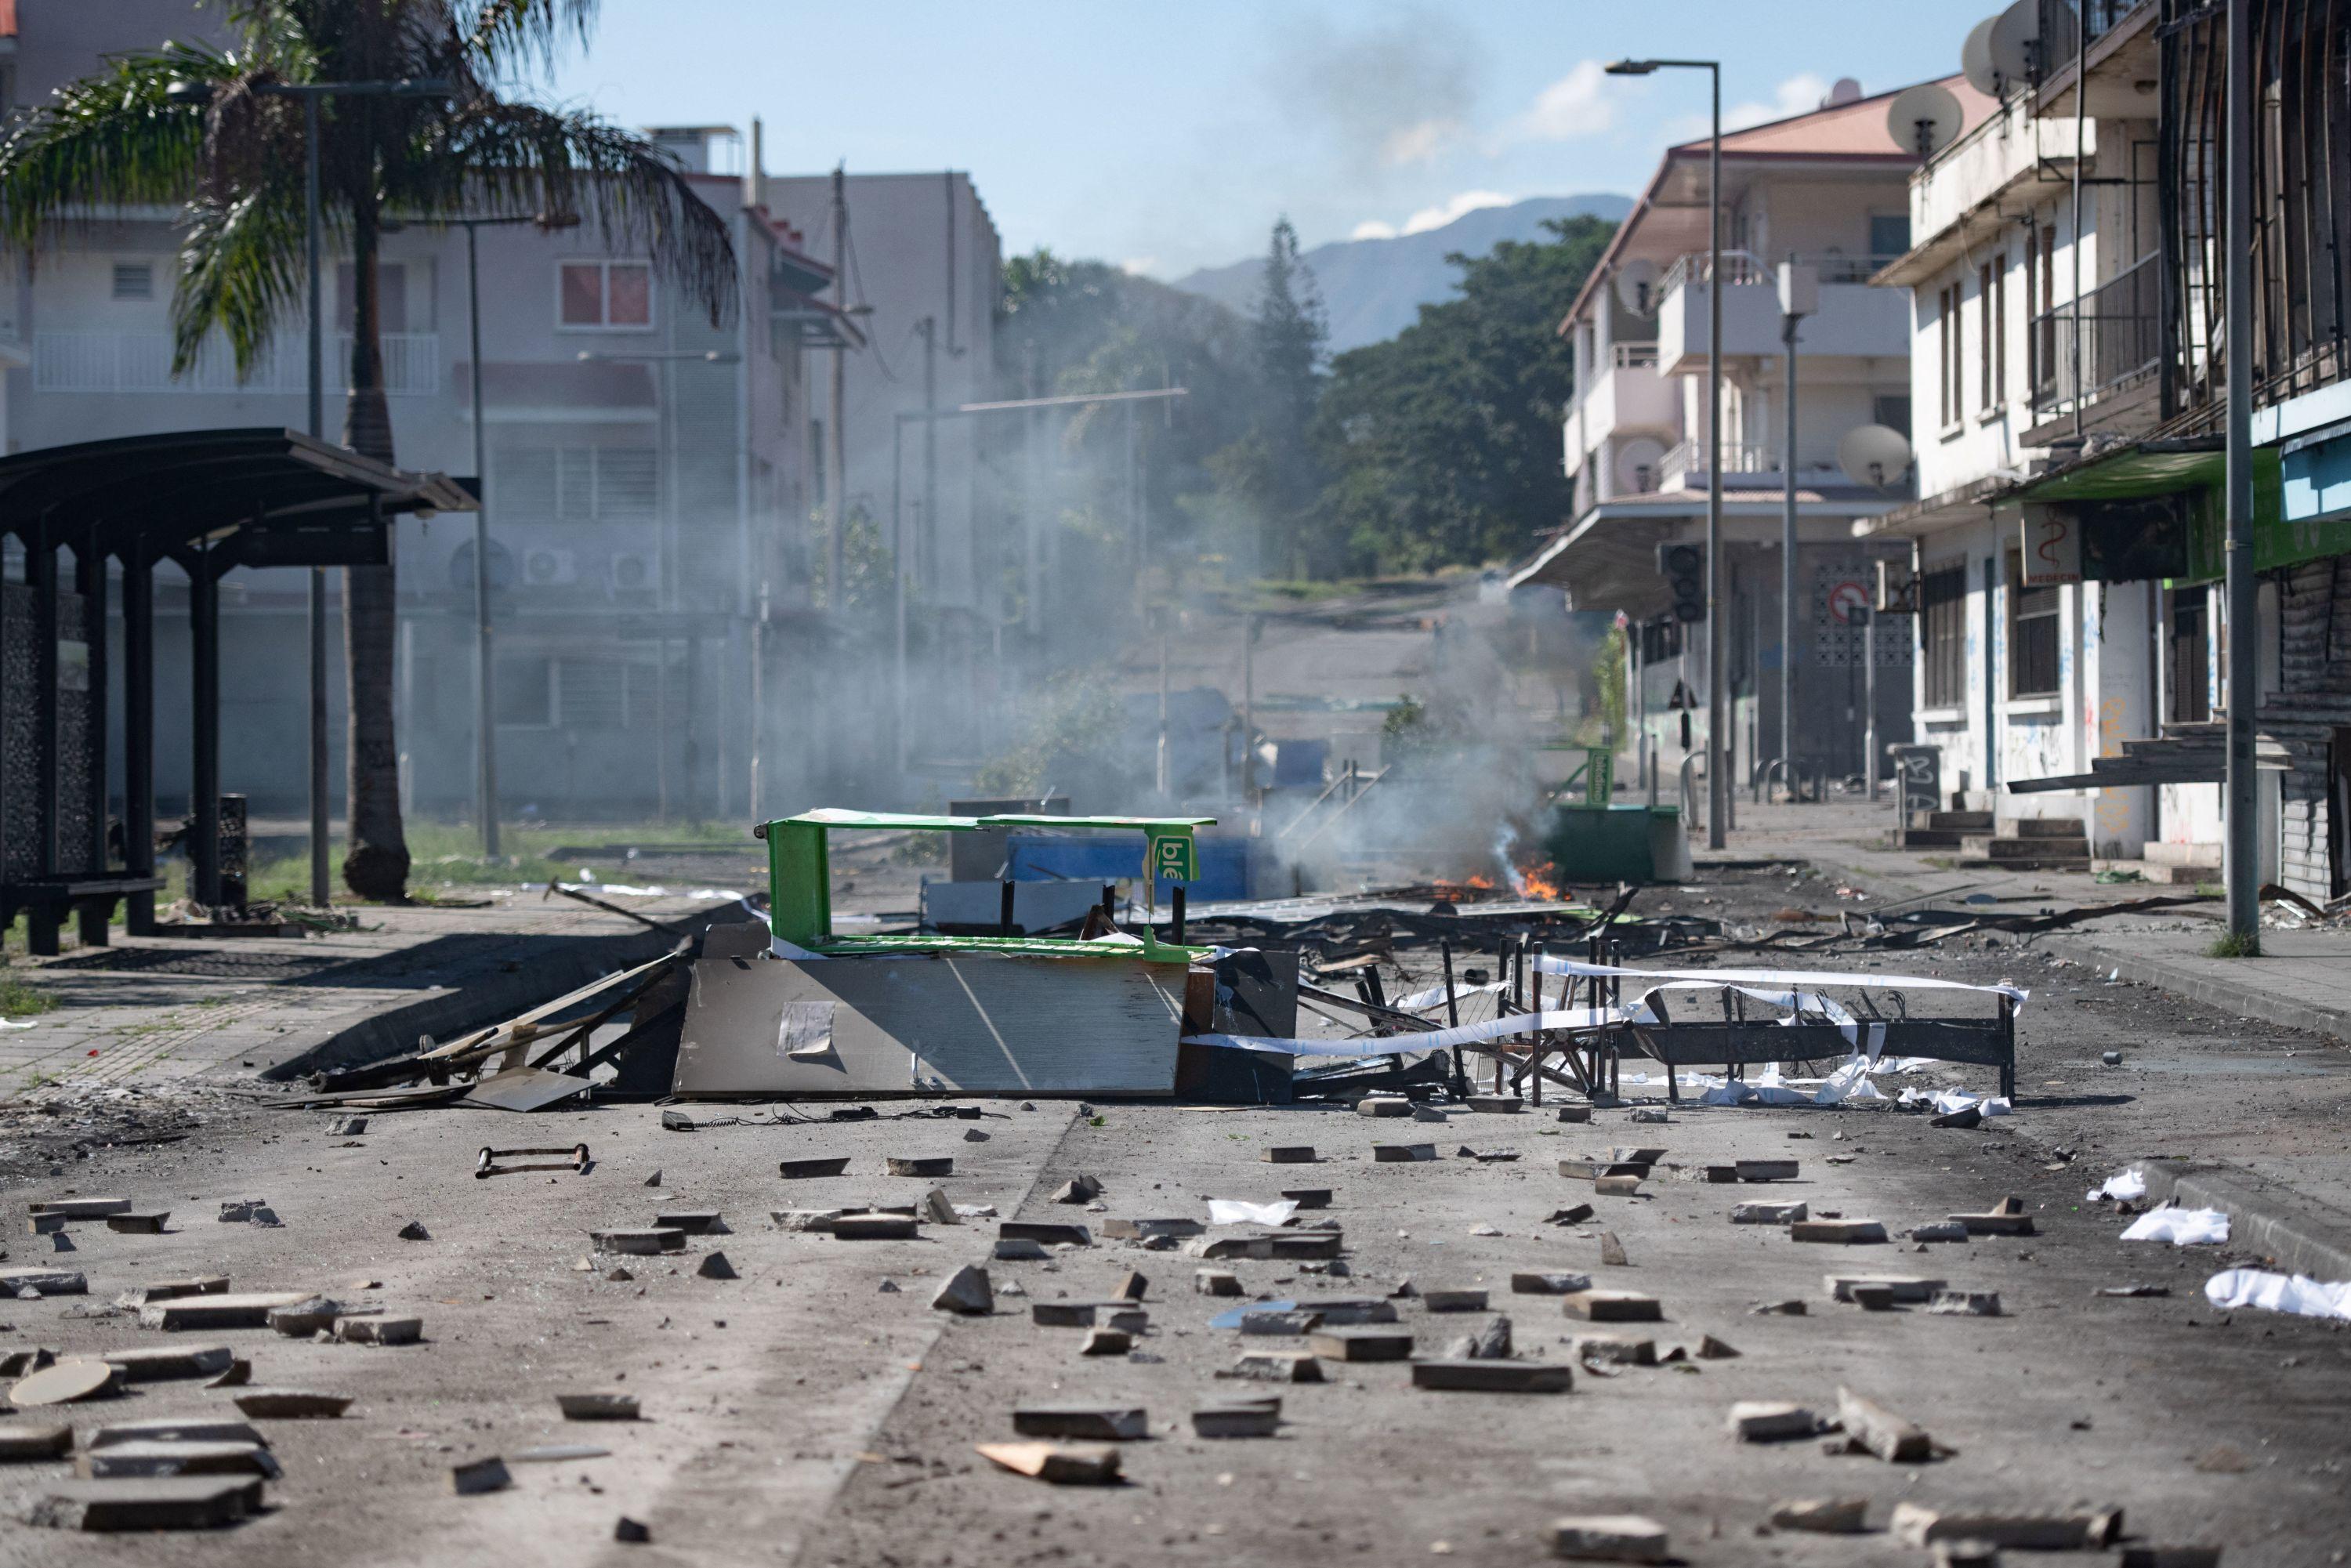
left=0, top=0, right=736, bottom=900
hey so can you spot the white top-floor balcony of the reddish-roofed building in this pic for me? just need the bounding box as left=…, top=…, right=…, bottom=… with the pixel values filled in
left=1657, top=252, right=1911, bottom=376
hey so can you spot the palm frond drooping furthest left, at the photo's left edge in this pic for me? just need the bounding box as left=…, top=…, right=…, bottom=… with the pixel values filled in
left=0, top=45, right=235, bottom=249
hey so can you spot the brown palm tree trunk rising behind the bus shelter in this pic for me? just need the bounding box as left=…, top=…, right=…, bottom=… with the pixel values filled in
left=343, top=202, right=409, bottom=903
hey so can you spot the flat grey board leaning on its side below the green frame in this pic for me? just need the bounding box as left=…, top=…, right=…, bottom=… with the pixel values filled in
left=672, top=952, right=1185, bottom=1098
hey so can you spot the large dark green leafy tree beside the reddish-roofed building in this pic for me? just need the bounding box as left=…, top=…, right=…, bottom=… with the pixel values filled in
left=1314, top=219, right=1613, bottom=571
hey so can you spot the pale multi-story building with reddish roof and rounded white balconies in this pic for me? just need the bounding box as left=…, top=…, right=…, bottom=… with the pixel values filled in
left=1512, top=80, right=1991, bottom=799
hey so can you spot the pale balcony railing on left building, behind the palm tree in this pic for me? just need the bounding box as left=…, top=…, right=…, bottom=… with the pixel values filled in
left=33, top=331, right=440, bottom=397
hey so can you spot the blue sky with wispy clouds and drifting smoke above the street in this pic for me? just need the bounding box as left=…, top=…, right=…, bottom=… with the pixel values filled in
left=548, top=0, right=1996, bottom=277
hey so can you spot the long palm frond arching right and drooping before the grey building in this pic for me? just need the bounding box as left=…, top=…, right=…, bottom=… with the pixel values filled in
left=407, top=99, right=738, bottom=327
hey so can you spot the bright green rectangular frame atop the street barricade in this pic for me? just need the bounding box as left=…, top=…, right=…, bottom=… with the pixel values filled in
left=752, top=806, right=1215, bottom=961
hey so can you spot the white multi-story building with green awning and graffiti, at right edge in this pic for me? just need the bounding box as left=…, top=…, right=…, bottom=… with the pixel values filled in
left=1869, top=0, right=2351, bottom=896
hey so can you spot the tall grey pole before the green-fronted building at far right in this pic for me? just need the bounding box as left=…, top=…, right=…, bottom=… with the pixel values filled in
left=2219, top=0, right=2262, bottom=957
